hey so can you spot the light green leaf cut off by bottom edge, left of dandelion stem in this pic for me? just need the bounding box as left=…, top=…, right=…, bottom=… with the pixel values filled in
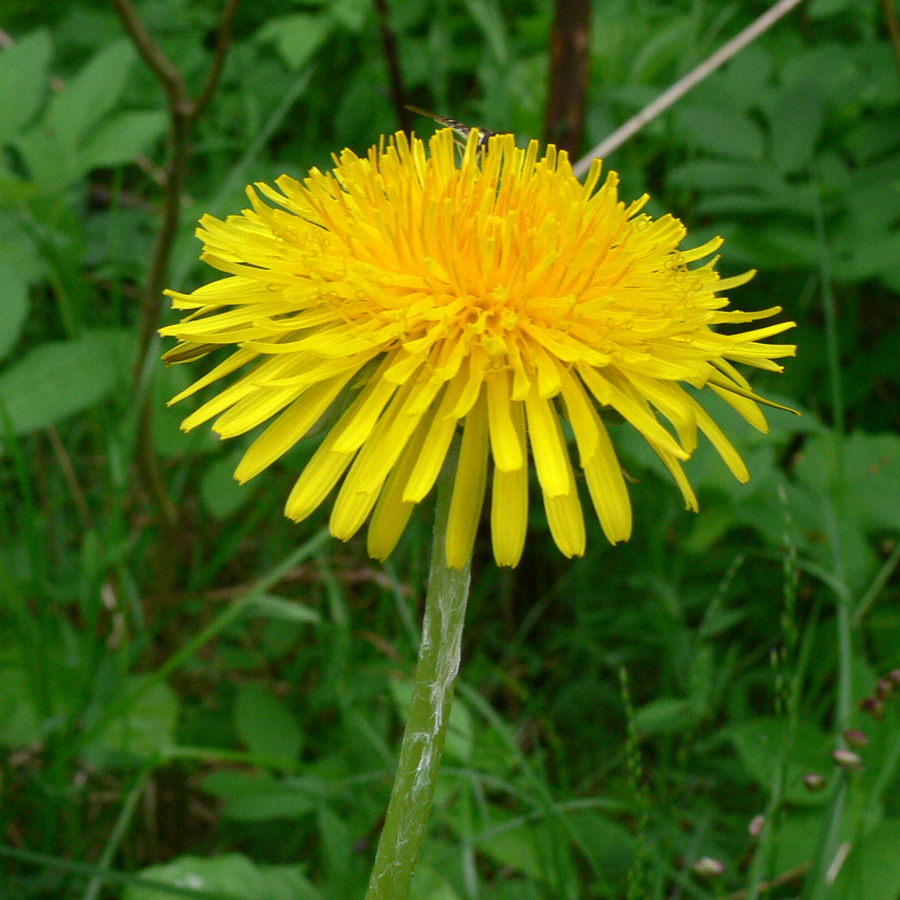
left=122, top=853, right=321, bottom=900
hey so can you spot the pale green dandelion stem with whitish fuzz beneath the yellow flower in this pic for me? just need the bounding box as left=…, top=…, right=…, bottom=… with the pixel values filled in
left=365, top=442, right=471, bottom=900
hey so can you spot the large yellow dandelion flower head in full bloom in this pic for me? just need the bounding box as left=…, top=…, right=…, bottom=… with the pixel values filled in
left=161, top=129, right=794, bottom=567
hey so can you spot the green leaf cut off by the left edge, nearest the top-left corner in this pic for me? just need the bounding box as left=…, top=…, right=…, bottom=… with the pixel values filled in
left=0, top=30, right=53, bottom=143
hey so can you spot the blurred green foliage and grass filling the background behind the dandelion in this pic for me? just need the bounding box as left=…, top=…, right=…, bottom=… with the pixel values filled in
left=0, top=0, right=900, bottom=900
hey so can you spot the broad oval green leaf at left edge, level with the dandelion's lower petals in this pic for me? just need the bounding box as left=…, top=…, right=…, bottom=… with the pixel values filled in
left=0, top=330, right=131, bottom=434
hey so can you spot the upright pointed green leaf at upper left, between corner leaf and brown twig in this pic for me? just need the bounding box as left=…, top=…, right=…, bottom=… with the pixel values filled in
left=46, top=40, right=135, bottom=150
